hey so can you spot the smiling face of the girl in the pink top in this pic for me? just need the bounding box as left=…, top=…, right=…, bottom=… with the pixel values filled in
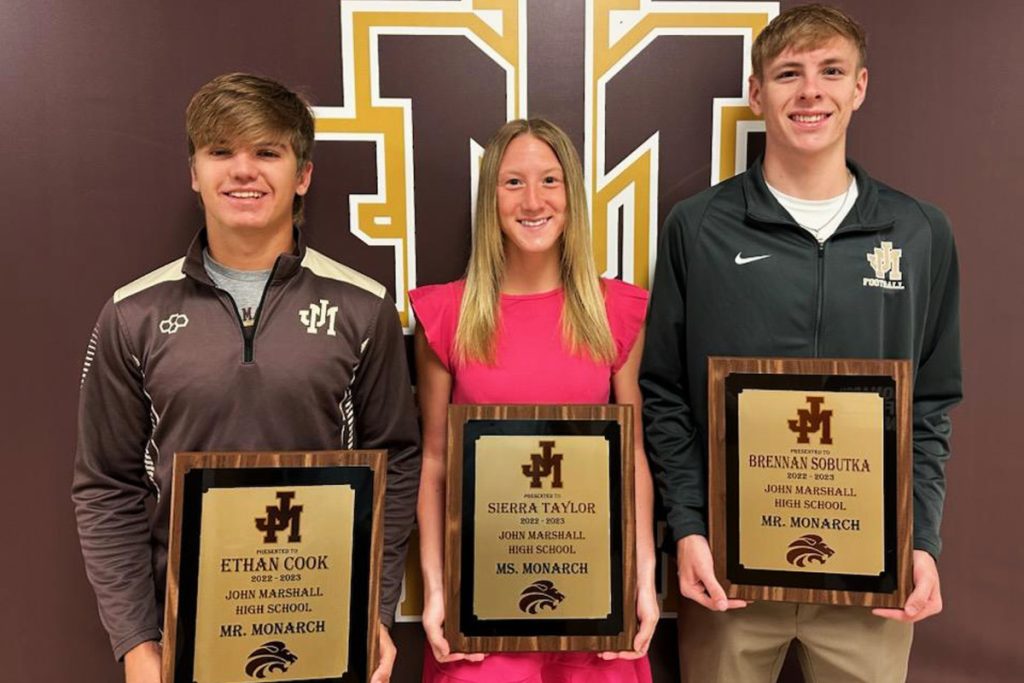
left=498, top=133, right=566, bottom=256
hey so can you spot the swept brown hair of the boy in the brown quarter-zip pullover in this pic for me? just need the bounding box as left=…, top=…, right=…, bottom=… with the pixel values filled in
left=185, top=73, right=314, bottom=225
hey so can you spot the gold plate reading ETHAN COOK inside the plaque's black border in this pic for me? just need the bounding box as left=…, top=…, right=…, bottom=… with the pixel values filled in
left=194, top=484, right=355, bottom=683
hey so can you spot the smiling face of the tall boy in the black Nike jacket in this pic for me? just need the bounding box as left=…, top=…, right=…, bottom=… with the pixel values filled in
left=750, top=36, right=867, bottom=163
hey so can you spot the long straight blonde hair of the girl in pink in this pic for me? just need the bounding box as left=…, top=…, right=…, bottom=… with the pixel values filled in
left=455, top=119, right=616, bottom=364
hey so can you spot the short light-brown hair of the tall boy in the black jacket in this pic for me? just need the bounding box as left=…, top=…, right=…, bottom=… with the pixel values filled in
left=751, top=4, right=867, bottom=78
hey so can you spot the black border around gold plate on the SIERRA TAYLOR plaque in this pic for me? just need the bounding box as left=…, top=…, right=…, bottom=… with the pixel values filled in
left=459, top=419, right=625, bottom=638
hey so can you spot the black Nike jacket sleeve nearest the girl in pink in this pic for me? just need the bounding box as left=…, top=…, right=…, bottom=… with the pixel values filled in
left=640, top=209, right=708, bottom=541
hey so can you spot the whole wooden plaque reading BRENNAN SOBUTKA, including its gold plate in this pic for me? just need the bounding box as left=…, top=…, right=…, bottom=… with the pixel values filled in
left=708, top=357, right=913, bottom=608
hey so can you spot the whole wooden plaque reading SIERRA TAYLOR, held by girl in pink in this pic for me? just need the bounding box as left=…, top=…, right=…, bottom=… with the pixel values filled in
left=444, top=405, right=637, bottom=652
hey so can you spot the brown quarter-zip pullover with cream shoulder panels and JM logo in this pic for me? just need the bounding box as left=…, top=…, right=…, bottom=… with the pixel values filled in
left=72, top=231, right=420, bottom=658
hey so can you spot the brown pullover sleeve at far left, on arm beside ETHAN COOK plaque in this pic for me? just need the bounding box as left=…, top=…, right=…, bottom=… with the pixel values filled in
left=72, top=301, right=161, bottom=659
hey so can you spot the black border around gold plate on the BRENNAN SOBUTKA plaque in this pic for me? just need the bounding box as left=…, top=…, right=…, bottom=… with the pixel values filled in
left=725, top=373, right=899, bottom=594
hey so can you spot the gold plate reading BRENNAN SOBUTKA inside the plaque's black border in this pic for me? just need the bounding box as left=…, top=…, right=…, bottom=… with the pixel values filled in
left=738, top=389, right=885, bottom=577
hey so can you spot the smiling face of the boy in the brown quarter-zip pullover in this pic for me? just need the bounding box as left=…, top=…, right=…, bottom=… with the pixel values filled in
left=191, top=138, right=312, bottom=233
